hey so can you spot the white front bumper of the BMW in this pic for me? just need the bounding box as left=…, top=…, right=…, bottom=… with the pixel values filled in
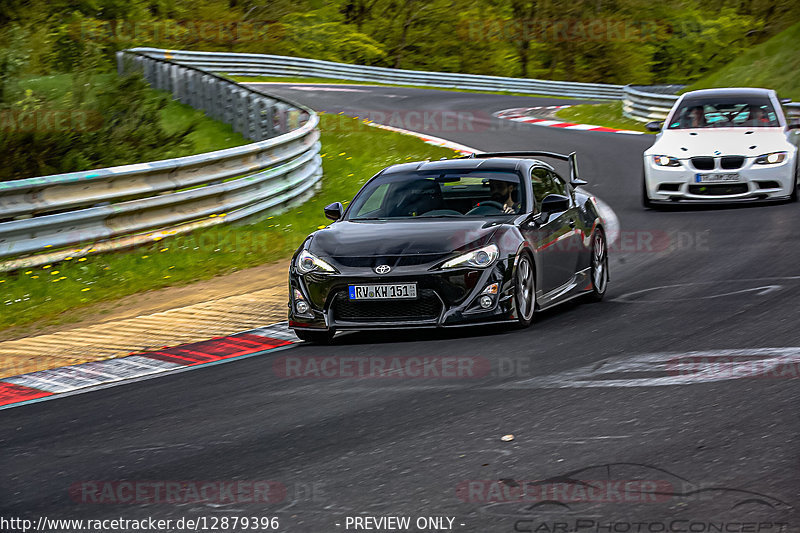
left=644, top=155, right=796, bottom=203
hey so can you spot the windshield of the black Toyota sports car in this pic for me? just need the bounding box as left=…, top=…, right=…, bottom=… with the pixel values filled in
left=347, top=170, right=523, bottom=220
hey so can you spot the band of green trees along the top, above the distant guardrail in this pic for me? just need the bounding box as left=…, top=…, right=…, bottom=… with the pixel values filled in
left=0, top=0, right=800, bottom=84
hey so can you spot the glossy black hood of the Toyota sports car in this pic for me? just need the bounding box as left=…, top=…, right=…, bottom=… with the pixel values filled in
left=308, top=219, right=504, bottom=257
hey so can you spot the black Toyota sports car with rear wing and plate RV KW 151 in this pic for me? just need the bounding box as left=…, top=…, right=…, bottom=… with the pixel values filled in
left=289, top=152, right=608, bottom=343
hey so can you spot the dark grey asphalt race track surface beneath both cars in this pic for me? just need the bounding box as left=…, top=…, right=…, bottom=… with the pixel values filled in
left=0, top=85, right=800, bottom=533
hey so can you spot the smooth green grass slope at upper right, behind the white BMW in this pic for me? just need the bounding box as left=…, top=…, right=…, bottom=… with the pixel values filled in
left=685, top=22, right=800, bottom=100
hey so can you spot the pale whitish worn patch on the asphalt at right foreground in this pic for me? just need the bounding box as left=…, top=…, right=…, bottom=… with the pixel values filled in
left=490, top=346, right=800, bottom=389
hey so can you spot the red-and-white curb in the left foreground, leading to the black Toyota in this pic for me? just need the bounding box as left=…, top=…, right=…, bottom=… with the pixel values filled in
left=0, top=322, right=298, bottom=409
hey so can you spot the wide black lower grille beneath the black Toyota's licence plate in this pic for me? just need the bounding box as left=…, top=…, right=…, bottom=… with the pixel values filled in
left=333, top=289, right=442, bottom=322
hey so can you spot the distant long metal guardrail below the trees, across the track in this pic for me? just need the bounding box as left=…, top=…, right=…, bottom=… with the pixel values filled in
left=128, top=48, right=623, bottom=100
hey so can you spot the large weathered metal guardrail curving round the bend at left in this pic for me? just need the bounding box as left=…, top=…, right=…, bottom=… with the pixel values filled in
left=0, top=51, right=322, bottom=271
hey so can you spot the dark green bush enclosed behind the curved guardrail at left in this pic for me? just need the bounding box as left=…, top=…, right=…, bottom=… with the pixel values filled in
left=0, top=74, right=197, bottom=180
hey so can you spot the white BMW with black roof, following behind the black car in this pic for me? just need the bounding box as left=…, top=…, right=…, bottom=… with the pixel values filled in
left=642, top=88, right=800, bottom=207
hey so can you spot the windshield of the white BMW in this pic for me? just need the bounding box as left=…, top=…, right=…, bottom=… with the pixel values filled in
left=669, top=96, right=780, bottom=130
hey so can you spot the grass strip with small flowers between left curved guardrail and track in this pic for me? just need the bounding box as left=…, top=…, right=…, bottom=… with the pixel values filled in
left=0, top=115, right=454, bottom=329
